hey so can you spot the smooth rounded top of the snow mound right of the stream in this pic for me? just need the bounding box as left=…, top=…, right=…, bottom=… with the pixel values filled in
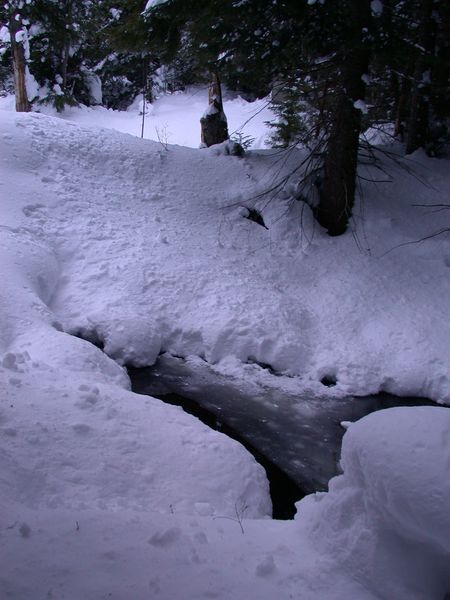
left=342, top=407, right=450, bottom=555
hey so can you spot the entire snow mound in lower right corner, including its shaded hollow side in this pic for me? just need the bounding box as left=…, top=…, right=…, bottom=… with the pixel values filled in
left=297, top=407, right=450, bottom=600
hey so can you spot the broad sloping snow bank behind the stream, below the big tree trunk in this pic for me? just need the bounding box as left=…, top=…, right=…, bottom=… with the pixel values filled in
left=2, top=113, right=450, bottom=402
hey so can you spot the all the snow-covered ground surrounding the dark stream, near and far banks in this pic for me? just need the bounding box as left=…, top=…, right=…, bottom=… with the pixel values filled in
left=0, top=91, right=450, bottom=600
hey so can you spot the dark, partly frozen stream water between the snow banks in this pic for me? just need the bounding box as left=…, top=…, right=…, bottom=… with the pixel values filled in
left=128, top=355, right=434, bottom=518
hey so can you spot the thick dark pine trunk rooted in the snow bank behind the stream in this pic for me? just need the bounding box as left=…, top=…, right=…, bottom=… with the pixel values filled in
left=311, top=0, right=371, bottom=235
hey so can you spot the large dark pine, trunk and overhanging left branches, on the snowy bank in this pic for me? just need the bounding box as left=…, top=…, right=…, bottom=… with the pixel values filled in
left=142, top=0, right=370, bottom=235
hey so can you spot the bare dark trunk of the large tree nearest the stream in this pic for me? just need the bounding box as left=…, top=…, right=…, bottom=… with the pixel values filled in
left=316, top=0, right=370, bottom=236
